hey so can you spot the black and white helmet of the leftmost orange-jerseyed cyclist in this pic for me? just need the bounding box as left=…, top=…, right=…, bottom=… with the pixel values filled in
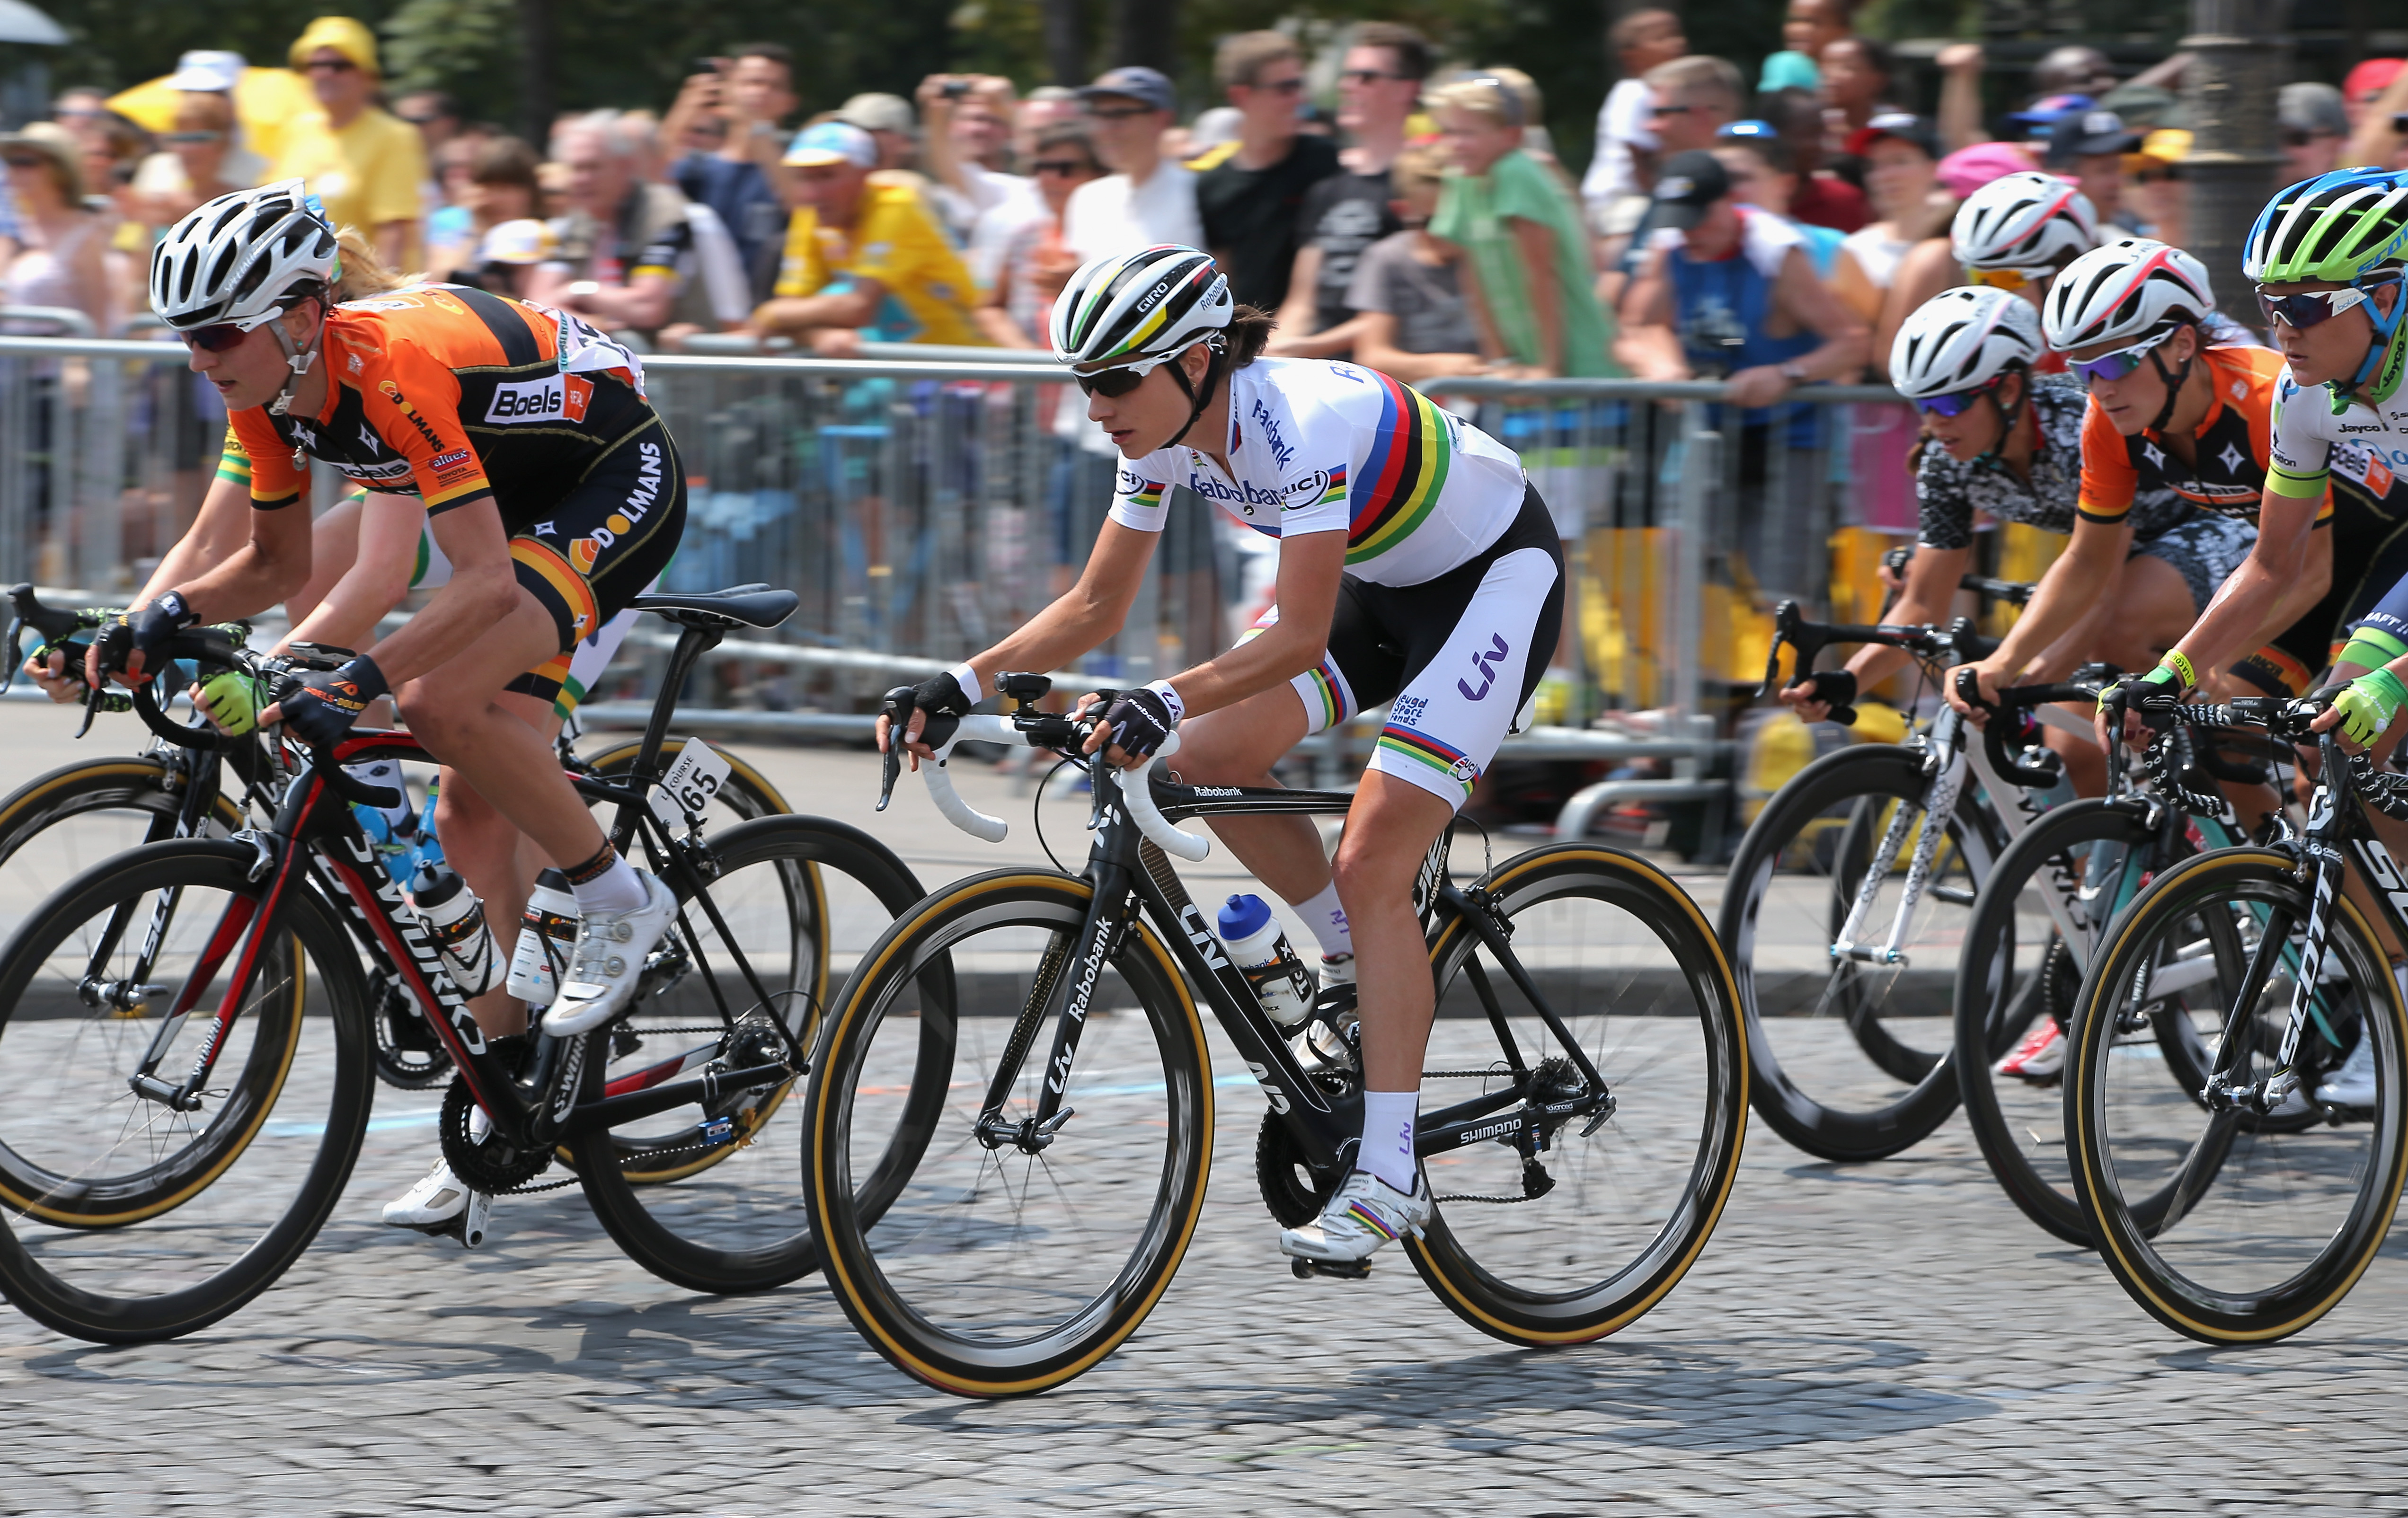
left=152, top=178, right=342, bottom=332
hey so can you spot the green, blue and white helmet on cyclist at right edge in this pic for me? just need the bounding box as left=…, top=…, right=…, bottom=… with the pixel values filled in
left=2242, top=168, right=2408, bottom=406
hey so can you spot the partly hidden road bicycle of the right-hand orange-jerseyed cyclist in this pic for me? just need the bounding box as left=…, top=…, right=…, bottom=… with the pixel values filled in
left=1953, top=679, right=2268, bottom=1249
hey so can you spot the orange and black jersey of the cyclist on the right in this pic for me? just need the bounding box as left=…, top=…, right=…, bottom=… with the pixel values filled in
left=2073, top=346, right=2333, bottom=527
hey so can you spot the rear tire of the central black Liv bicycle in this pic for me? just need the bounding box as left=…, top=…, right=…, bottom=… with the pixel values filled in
left=1406, top=844, right=1748, bottom=1345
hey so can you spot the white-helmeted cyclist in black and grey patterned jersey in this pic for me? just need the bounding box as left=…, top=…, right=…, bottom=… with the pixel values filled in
left=1782, top=283, right=2256, bottom=794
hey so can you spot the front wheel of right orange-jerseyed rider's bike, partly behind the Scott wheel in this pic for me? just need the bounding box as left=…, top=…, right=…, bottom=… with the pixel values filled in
left=1955, top=799, right=2167, bottom=1249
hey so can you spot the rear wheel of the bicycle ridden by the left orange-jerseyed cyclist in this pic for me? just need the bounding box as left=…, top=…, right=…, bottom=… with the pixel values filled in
left=566, top=815, right=954, bottom=1292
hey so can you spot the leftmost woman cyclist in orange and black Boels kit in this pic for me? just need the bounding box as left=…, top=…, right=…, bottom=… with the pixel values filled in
left=87, top=180, right=684, bottom=1229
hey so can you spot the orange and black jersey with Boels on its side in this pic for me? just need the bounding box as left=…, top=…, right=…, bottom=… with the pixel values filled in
left=231, top=284, right=653, bottom=534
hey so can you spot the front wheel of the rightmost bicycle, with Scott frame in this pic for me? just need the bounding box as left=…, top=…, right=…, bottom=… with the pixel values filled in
left=2063, top=847, right=2408, bottom=1345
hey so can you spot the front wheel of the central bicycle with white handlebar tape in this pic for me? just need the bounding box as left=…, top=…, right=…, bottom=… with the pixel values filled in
left=804, top=871, right=1211, bottom=1398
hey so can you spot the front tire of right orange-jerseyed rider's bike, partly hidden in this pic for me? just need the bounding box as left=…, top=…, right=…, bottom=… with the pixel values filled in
left=1955, top=799, right=2158, bottom=1249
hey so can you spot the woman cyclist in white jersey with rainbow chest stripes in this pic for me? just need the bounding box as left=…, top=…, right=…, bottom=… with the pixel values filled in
left=881, top=246, right=1563, bottom=1261
